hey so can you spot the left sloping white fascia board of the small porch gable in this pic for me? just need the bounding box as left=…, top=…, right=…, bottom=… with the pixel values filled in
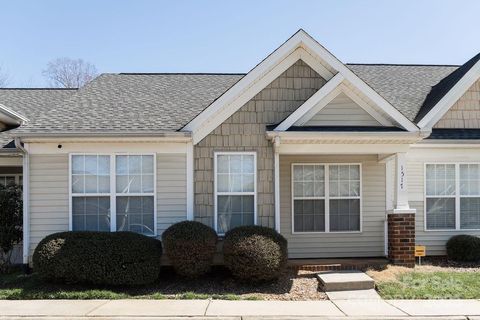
left=274, top=73, right=345, bottom=131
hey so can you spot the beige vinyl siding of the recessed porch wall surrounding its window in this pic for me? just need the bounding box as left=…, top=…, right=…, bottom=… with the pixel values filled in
left=280, top=155, right=385, bottom=258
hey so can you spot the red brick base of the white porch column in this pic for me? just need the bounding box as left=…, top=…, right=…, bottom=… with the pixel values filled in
left=388, top=213, right=415, bottom=268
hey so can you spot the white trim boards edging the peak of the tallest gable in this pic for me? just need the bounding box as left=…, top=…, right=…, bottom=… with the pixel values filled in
left=181, top=30, right=418, bottom=144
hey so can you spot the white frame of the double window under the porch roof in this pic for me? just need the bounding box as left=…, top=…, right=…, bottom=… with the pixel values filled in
left=290, top=162, right=363, bottom=234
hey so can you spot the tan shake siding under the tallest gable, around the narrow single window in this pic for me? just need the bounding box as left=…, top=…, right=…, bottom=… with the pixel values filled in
left=194, top=60, right=326, bottom=228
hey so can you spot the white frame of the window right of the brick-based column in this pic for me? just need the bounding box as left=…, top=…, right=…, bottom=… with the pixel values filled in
left=423, top=161, right=480, bottom=232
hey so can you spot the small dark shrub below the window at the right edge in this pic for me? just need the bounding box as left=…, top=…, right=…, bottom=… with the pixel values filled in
left=447, top=234, right=480, bottom=262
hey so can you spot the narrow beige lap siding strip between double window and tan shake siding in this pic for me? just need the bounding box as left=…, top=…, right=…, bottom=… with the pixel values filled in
left=157, top=154, right=187, bottom=236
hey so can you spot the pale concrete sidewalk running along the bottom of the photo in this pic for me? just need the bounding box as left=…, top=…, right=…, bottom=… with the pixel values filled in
left=0, top=300, right=480, bottom=320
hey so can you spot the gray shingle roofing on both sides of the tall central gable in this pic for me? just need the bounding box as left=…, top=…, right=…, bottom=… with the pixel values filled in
left=0, top=64, right=472, bottom=143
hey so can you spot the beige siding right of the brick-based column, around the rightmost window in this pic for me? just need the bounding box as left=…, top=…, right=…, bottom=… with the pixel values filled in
left=407, top=158, right=480, bottom=256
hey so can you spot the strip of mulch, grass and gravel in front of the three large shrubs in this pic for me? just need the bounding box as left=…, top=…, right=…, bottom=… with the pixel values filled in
left=0, top=271, right=325, bottom=300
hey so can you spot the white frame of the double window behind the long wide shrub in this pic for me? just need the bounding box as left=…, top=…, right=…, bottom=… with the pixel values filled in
left=68, top=152, right=158, bottom=237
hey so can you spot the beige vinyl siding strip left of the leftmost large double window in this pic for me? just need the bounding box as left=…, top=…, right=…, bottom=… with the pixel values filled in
left=30, top=154, right=69, bottom=255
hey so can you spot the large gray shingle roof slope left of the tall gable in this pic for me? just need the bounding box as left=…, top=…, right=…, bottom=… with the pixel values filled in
left=17, top=74, right=243, bottom=134
